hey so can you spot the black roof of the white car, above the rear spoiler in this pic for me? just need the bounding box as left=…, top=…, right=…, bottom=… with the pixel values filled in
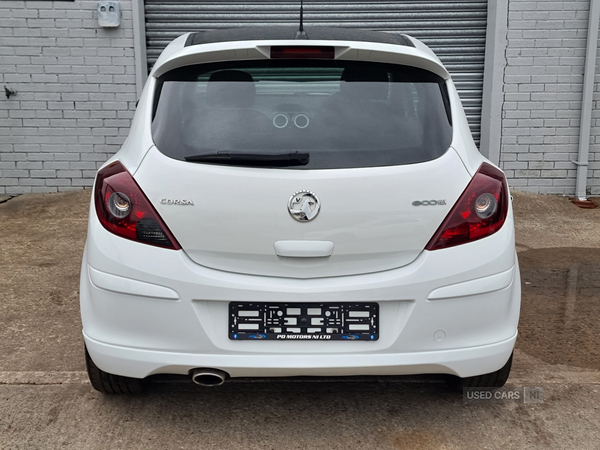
left=185, top=26, right=414, bottom=47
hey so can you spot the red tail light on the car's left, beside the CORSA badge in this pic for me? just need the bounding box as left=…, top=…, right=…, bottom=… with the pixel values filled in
left=94, top=161, right=181, bottom=250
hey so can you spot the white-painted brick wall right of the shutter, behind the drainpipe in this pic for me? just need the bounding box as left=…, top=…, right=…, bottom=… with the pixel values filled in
left=500, top=0, right=600, bottom=195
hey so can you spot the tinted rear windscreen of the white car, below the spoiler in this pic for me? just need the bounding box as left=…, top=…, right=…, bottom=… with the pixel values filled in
left=152, top=60, right=452, bottom=169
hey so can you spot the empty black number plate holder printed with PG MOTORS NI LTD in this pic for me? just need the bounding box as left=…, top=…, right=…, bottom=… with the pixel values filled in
left=229, top=302, right=379, bottom=341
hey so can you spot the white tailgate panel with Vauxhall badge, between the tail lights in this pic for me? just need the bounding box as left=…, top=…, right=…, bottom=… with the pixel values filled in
left=135, top=147, right=471, bottom=278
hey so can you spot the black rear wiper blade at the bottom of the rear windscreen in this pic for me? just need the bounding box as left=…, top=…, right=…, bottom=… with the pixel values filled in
left=184, top=151, right=310, bottom=167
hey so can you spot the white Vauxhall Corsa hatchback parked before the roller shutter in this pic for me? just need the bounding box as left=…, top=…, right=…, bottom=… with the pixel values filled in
left=81, top=27, right=520, bottom=393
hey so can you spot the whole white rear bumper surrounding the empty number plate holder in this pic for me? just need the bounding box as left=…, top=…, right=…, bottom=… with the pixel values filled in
left=80, top=211, right=521, bottom=378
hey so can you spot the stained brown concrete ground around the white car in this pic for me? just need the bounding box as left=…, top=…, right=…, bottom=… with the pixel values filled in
left=0, top=191, right=600, bottom=450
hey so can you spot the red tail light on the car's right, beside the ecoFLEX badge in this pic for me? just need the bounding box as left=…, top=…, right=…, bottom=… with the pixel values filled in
left=425, top=163, right=508, bottom=250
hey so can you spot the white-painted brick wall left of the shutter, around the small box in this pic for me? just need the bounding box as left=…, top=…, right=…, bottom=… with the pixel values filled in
left=0, top=0, right=136, bottom=194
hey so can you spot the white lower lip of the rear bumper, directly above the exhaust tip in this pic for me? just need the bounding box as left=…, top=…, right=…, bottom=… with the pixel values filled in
left=84, top=333, right=517, bottom=378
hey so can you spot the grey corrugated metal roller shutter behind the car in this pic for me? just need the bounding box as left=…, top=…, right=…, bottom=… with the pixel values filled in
left=145, top=0, right=487, bottom=142
